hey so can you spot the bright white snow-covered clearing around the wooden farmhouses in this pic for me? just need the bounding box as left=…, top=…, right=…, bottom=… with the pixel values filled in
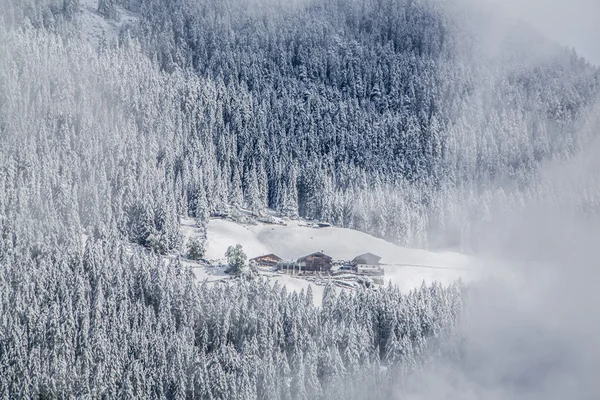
left=190, top=219, right=481, bottom=304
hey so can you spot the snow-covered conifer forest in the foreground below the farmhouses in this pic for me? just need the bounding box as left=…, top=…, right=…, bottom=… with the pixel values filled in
left=0, top=234, right=463, bottom=399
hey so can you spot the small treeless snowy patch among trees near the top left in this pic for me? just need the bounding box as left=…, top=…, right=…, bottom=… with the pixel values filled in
left=77, top=0, right=139, bottom=47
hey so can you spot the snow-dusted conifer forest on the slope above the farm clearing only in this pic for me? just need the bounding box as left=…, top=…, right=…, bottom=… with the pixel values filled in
left=3, top=0, right=600, bottom=249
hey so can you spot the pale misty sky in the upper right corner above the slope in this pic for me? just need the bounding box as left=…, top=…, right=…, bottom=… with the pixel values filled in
left=484, top=0, right=600, bottom=65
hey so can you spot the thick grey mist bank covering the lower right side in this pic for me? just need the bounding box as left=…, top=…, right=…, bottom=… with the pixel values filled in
left=400, top=98, right=600, bottom=400
